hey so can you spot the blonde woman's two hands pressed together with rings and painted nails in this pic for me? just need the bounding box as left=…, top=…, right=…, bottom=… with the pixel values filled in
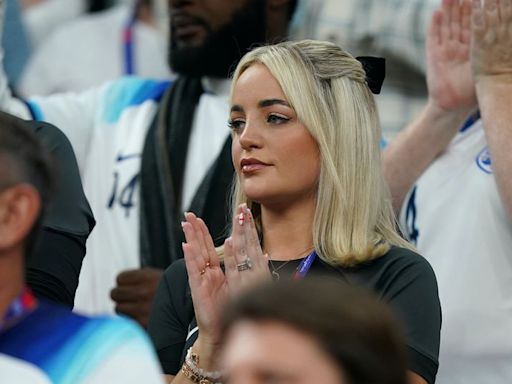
left=182, top=204, right=271, bottom=342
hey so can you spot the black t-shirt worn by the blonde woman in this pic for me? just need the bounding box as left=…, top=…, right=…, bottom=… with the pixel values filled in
left=148, top=247, right=441, bottom=383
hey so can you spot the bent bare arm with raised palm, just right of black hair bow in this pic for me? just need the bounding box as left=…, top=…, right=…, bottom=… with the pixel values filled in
left=383, top=0, right=476, bottom=213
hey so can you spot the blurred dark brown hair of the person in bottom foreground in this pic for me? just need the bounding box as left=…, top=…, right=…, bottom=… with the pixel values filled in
left=222, top=278, right=407, bottom=384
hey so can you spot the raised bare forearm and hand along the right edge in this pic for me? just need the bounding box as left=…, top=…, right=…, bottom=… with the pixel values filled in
left=471, top=0, right=512, bottom=218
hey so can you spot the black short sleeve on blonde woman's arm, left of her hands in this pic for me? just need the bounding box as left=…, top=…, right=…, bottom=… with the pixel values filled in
left=148, top=259, right=194, bottom=375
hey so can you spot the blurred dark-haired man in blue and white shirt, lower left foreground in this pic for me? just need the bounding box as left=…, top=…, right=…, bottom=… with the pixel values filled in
left=0, top=110, right=162, bottom=384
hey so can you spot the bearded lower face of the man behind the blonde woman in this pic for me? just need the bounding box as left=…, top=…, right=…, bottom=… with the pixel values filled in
left=169, top=0, right=266, bottom=78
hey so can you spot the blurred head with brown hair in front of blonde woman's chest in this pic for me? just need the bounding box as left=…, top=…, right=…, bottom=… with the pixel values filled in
left=220, top=279, right=407, bottom=384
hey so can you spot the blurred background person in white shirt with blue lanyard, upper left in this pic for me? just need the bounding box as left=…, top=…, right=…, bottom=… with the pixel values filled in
left=19, top=0, right=170, bottom=96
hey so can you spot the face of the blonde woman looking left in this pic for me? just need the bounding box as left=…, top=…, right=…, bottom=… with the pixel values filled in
left=230, top=64, right=320, bottom=205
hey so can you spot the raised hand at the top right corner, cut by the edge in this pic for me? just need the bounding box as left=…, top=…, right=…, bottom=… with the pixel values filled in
left=471, top=0, right=512, bottom=84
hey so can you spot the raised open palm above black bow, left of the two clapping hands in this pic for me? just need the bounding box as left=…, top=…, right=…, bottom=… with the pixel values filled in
left=427, top=0, right=476, bottom=110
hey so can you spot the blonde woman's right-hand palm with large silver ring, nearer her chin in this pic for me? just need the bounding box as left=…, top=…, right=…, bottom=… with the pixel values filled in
left=224, top=204, right=271, bottom=295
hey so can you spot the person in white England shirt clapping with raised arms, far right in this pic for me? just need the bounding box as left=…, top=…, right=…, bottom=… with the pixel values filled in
left=384, top=0, right=512, bottom=384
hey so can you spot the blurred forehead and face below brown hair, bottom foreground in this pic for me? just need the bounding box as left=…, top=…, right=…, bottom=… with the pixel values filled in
left=221, top=321, right=346, bottom=384
